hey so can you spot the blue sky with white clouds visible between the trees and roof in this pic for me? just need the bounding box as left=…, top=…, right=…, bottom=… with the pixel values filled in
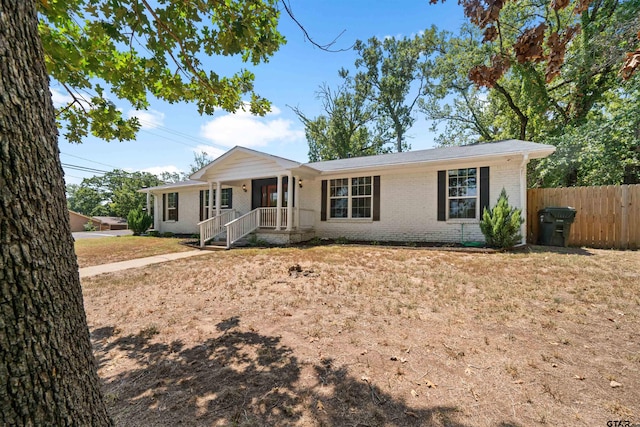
left=52, top=0, right=464, bottom=184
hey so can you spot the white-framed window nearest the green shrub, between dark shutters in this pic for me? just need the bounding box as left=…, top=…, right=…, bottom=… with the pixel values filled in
left=447, top=168, right=478, bottom=219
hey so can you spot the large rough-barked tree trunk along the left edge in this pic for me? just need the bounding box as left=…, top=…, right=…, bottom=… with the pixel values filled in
left=0, top=0, right=111, bottom=426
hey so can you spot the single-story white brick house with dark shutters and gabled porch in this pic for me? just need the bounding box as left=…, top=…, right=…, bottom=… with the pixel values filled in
left=140, top=140, right=555, bottom=246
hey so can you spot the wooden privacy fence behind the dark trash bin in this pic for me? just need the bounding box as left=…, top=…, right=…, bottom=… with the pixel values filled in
left=527, top=184, right=640, bottom=249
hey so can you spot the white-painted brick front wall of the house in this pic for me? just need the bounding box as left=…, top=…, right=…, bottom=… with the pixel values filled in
left=157, top=156, right=522, bottom=243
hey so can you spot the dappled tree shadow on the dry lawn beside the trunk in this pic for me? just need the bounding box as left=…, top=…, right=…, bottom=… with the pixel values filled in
left=92, top=317, right=511, bottom=427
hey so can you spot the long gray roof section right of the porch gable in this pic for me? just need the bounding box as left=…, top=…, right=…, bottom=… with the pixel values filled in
left=305, top=139, right=555, bottom=172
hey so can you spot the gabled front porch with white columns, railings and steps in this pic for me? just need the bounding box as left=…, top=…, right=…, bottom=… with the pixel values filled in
left=192, top=147, right=315, bottom=247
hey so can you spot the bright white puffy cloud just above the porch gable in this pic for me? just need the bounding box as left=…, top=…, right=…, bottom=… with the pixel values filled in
left=200, top=106, right=304, bottom=147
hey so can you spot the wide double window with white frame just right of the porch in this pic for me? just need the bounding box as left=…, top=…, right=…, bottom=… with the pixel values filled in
left=329, top=176, right=373, bottom=218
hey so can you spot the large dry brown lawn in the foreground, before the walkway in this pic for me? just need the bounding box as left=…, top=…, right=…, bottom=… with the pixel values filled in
left=83, top=246, right=640, bottom=427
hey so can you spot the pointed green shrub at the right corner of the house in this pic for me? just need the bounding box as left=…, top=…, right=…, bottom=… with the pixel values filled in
left=480, top=188, right=524, bottom=248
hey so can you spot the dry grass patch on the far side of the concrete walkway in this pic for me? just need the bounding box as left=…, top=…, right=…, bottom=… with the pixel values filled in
left=75, top=236, right=192, bottom=268
